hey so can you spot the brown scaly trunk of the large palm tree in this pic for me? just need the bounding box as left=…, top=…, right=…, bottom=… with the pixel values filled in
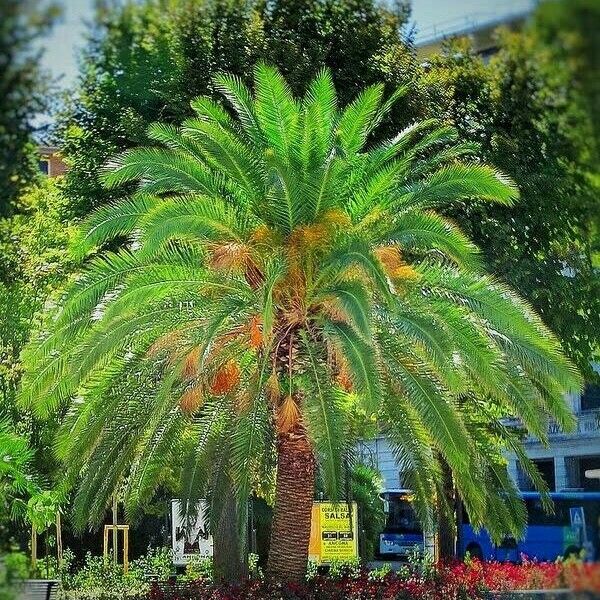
left=267, top=428, right=315, bottom=582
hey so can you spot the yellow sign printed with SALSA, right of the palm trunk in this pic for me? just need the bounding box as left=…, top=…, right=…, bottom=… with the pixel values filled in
left=308, top=502, right=358, bottom=563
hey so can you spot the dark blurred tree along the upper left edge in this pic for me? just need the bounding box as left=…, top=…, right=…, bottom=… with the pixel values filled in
left=0, top=0, right=57, bottom=217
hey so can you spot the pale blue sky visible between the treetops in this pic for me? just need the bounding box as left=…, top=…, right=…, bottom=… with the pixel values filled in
left=43, top=0, right=535, bottom=88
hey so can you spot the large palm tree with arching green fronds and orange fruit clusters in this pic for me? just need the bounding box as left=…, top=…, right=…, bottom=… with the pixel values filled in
left=21, top=65, right=580, bottom=579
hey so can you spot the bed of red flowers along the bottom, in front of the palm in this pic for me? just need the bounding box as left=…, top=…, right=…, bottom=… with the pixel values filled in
left=148, top=561, right=600, bottom=600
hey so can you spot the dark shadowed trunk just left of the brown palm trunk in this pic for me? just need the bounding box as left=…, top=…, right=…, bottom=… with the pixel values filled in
left=213, top=487, right=248, bottom=584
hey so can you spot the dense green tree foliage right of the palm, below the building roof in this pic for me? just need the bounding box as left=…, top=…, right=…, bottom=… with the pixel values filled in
left=422, top=16, right=600, bottom=377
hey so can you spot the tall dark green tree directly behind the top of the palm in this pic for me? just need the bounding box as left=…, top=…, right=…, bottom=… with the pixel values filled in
left=59, top=0, right=410, bottom=213
